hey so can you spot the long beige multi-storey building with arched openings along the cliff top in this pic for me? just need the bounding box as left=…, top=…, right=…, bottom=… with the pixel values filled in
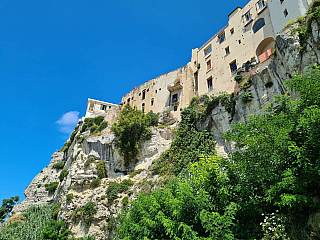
left=117, top=0, right=312, bottom=122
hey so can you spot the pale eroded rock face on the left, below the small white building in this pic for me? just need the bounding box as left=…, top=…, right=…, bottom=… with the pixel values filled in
left=11, top=128, right=174, bottom=239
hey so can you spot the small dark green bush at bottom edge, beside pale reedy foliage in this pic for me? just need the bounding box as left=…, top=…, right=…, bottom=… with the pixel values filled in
left=40, top=220, right=69, bottom=240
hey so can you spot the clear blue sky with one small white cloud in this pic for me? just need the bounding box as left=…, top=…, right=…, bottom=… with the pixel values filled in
left=0, top=0, right=248, bottom=200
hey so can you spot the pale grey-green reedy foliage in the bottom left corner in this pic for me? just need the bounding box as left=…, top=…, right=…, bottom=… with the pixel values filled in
left=0, top=206, right=52, bottom=240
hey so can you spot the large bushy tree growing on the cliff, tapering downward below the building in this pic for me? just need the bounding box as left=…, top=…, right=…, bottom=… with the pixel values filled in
left=111, top=104, right=150, bottom=167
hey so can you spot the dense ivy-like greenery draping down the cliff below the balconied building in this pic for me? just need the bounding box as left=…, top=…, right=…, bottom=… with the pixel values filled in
left=152, top=98, right=215, bottom=177
